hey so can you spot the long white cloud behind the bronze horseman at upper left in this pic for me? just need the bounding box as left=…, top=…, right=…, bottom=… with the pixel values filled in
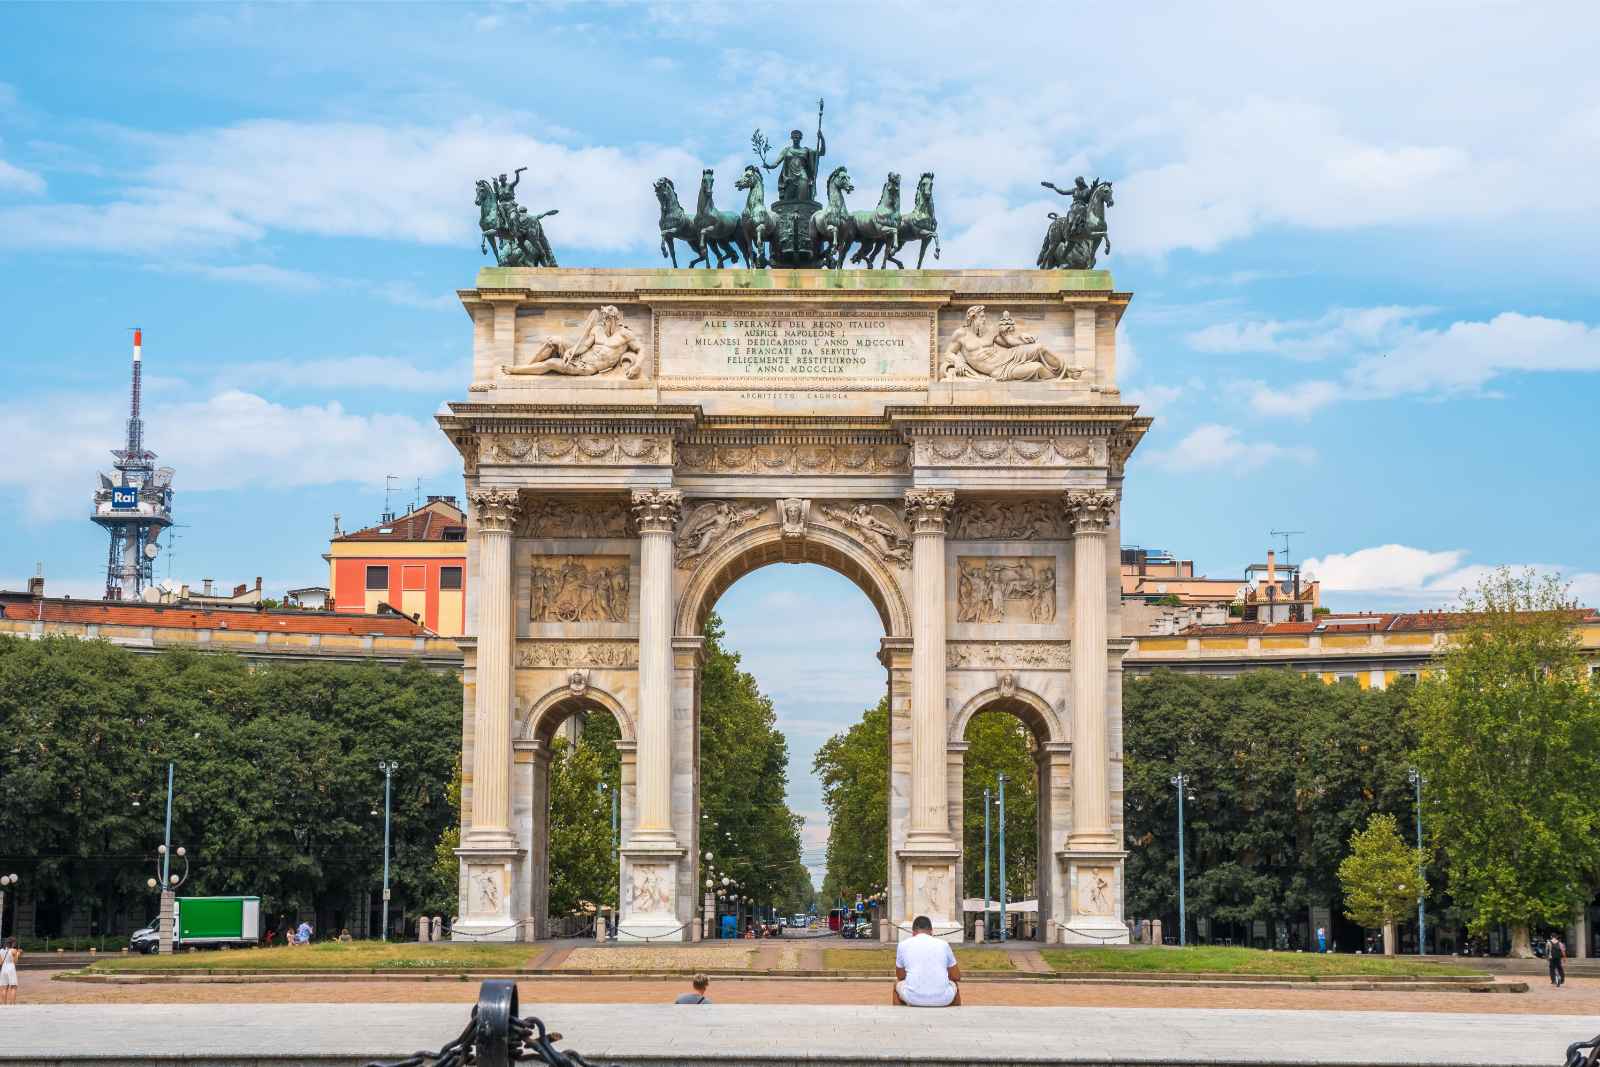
left=0, top=118, right=698, bottom=251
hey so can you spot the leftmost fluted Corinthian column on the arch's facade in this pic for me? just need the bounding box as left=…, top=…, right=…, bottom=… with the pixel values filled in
left=462, top=490, right=517, bottom=845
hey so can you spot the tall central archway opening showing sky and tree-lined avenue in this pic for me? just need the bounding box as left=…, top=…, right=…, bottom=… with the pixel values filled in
left=698, top=556, right=893, bottom=936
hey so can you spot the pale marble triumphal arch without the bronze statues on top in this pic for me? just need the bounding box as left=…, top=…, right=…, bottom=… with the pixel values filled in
left=438, top=267, right=1149, bottom=944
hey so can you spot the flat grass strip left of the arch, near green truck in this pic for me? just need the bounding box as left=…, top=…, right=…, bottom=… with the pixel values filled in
left=91, top=941, right=534, bottom=971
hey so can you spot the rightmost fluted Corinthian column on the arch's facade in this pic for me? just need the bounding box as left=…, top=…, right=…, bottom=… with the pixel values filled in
left=1066, top=490, right=1117, bottom=849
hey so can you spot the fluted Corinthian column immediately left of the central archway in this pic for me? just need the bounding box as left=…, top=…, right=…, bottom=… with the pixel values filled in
left=634, top=490, right=683, bottom=841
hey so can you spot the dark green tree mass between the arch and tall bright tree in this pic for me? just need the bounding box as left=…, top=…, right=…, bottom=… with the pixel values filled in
left=1123, top=670, right=1410, bottom=944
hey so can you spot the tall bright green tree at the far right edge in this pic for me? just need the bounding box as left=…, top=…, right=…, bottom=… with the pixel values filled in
left=1411, top=568, right=1600, bottom=955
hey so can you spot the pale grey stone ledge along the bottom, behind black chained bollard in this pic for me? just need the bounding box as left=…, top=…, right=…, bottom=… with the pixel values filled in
left=0, top=997, right=1597, bottom=1067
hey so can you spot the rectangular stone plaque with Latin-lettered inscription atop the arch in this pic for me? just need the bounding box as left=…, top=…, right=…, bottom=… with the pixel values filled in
left=656, top=307, right=934, bottom=389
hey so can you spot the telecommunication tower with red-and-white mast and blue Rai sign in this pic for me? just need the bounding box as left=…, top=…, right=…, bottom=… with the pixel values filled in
left=90, top=328, right=173, bottom=600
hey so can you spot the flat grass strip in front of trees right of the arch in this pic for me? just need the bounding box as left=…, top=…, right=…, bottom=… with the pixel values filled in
left=1040, top=945, right=1483, bottom=977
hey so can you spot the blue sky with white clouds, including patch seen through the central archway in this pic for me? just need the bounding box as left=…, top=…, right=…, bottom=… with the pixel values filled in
left=0, top=0, right=1600, bottom=883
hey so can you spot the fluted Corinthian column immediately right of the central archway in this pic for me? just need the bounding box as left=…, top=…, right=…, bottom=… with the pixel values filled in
left=906, top=490, right=955, bottom=841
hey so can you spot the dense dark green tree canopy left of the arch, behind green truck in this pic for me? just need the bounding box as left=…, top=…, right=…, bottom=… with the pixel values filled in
left=0, top=637, right=461, bottom=928
